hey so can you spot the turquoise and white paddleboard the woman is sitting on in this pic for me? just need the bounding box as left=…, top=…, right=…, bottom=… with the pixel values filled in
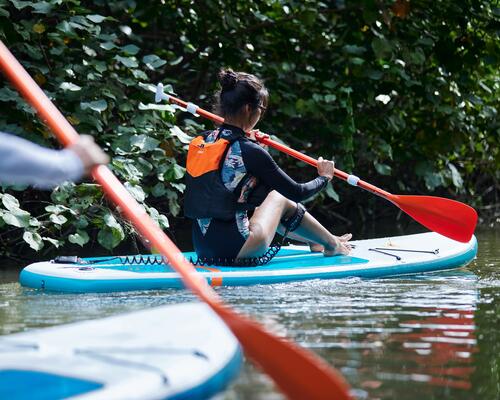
left=20, top=232, right=477, bottom=292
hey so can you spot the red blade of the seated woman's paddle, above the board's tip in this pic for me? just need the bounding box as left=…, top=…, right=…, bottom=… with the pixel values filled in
left=388, top=195, right=477, bottom=243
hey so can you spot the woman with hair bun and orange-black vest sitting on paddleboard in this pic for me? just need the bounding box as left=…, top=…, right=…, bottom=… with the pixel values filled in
left=185, top=69, right=352, bottom=264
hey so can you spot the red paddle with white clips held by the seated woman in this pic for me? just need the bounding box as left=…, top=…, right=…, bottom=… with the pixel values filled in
left=155, top=83, right=477, bottom=243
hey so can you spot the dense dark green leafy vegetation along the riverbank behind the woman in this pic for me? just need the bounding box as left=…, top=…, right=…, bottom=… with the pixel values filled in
left=0, top=0, right=500, bottom=258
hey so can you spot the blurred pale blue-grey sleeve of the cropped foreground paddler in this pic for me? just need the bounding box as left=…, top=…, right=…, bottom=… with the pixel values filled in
left=0, top=133, right=83, bottom=188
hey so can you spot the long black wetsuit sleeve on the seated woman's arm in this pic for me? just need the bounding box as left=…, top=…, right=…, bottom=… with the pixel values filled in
left=241, top=140, right=328, bottom=202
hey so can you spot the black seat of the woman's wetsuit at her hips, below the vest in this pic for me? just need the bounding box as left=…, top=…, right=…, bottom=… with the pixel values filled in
left=193, top=218, right=246, bottom=258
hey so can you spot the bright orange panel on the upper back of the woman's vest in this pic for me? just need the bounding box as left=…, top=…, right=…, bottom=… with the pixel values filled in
left=186, top=136, right=229, bottom=178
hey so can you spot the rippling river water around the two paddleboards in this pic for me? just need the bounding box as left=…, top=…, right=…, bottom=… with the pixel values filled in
left=0, top=229, right=500, bottom=400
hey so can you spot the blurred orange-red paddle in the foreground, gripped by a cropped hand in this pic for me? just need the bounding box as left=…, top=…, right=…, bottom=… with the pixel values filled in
left=0, top=41, right=351, bottom=400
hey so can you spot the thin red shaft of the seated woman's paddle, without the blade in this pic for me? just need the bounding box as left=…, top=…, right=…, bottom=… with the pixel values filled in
left=163, top=90, right=395, bottom=202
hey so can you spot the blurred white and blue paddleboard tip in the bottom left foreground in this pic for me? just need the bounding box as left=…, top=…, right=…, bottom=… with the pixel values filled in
left=0, top=303, right=242, bottom=400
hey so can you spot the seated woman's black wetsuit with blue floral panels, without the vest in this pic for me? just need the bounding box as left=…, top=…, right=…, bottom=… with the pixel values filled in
left=193, top=124, right=328, bottom=258
